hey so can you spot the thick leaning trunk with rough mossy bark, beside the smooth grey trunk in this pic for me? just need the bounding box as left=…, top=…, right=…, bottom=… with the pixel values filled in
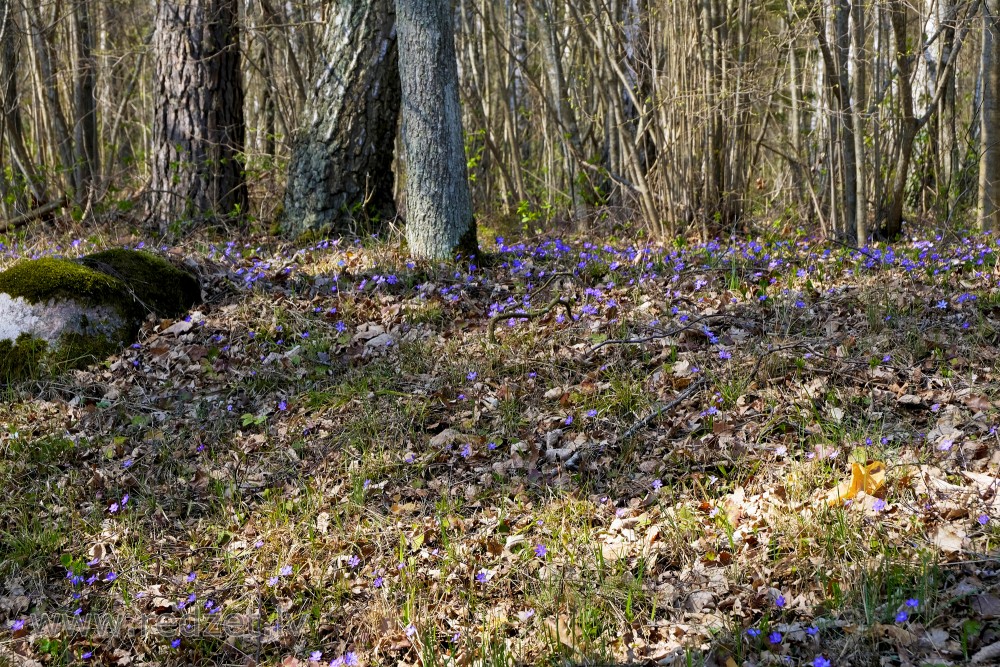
left=283, top=0, right=400, bottom=235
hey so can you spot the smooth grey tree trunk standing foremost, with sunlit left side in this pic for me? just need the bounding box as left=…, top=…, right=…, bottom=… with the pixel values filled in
left=396, top=0, right=478, bottom=259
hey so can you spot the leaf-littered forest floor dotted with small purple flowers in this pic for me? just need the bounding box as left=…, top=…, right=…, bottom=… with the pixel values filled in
left=0, top=223, right=1000, bottom=667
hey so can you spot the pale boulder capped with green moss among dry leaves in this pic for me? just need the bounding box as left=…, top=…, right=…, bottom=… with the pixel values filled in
left=0, top=249, right=201, bottom=382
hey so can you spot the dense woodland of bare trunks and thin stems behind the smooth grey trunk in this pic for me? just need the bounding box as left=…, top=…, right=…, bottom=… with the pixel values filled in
left=0, top=0, right=1000, bottom=244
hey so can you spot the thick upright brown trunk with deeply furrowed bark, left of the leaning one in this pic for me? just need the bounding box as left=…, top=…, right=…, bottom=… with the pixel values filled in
left=150, top=0, right=247, bottom=232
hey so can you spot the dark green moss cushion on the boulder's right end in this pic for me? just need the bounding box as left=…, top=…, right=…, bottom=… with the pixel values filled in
left=80, top=248, right=201, bottom=317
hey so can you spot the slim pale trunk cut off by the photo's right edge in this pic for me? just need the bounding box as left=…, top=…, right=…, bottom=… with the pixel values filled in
left=979, top=0, right=1000, bottom=231
